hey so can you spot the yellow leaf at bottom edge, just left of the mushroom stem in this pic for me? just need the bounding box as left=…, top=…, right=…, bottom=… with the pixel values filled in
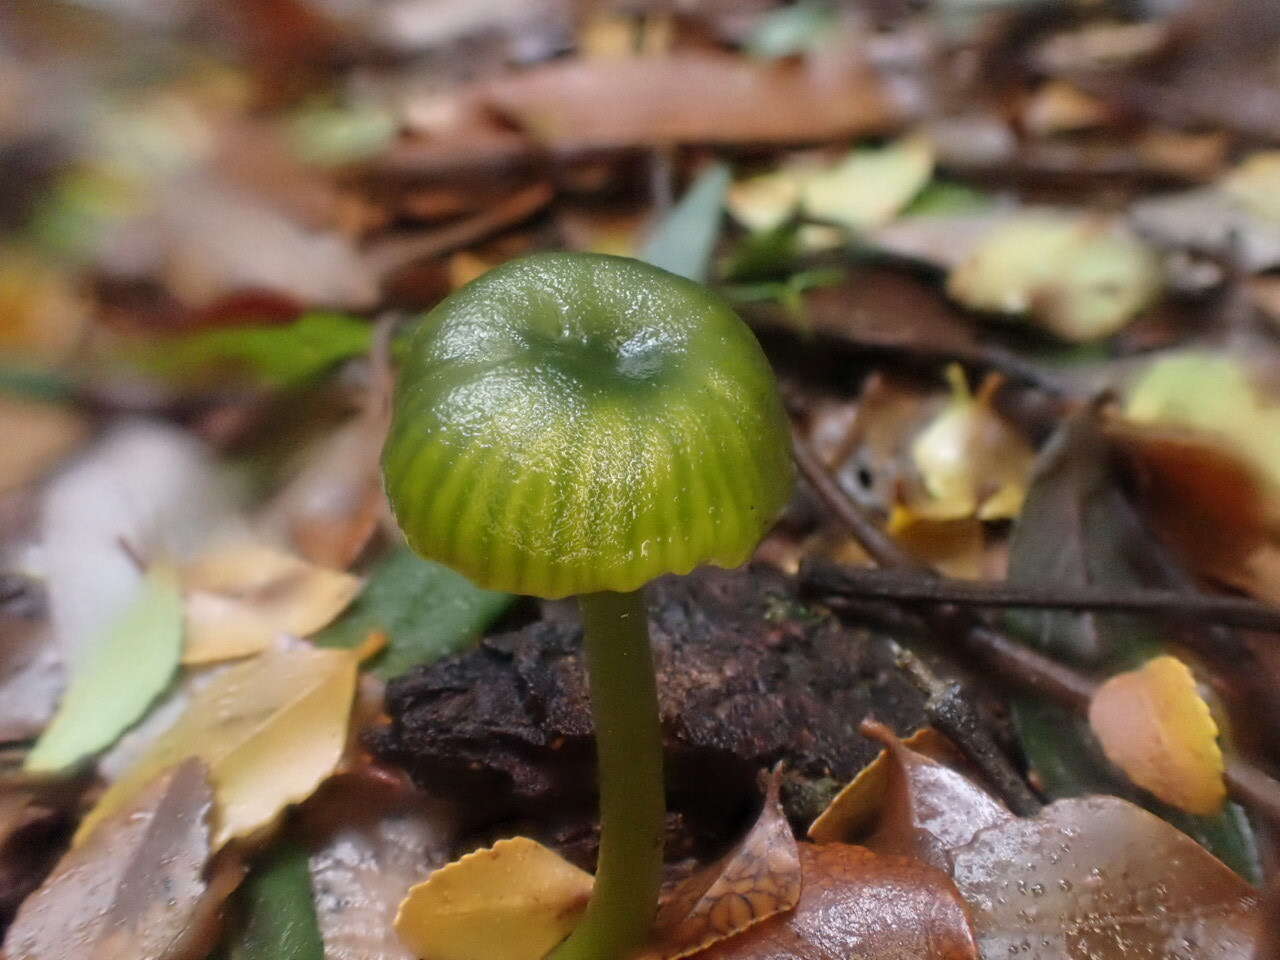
left=396, top=837, right=593, bottom=960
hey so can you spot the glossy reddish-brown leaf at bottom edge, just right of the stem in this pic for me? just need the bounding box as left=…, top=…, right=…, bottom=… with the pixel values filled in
left=698, top=844, right=978, bottom=960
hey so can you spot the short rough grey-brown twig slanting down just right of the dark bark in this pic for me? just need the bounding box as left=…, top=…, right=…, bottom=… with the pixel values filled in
left=893, top=644, right=1042, bottom=817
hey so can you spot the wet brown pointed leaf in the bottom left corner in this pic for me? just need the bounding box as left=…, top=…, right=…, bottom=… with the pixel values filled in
left=5, top=760, right=230, bottom=960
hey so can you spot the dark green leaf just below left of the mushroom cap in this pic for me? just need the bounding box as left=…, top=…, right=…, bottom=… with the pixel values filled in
left=315, top=547, right=515, bottom=678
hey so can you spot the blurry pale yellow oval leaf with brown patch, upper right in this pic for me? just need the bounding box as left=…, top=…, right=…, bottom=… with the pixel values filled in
left=947, top=212, right=1161, bottom=342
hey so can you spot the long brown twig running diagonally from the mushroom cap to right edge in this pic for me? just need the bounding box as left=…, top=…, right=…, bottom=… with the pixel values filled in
left=794, top=427, right=1280, bottom=824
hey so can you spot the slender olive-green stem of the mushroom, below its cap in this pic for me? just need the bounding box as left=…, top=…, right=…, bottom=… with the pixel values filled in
left=549, top=590, right=666, bottom=960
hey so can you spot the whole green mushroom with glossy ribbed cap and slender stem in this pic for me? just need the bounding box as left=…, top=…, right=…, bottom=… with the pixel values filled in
left=383, top=253, right=792, bottom=960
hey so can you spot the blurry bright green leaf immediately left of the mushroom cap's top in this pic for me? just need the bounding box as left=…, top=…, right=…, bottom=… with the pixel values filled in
left=142, top=312, right=372, bottom=387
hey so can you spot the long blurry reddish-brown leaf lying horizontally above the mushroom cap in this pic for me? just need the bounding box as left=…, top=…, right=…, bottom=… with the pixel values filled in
left=480, top=52, right=893, bottom=151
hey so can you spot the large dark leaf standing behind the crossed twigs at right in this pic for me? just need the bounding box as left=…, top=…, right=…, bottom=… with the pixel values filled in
left=1006, top=415, right=1260, bottom=882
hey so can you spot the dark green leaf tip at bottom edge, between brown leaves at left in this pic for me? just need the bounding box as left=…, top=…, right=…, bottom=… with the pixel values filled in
left=223, top=842, right=324, bottom=960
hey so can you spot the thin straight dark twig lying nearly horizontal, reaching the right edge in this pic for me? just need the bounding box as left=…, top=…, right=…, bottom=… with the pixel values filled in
left=800, top=561, right=1280, bottom=632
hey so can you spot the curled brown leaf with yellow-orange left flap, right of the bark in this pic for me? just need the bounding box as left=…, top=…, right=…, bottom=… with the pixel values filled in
left=809, top=721, right=1012, bottom=869
